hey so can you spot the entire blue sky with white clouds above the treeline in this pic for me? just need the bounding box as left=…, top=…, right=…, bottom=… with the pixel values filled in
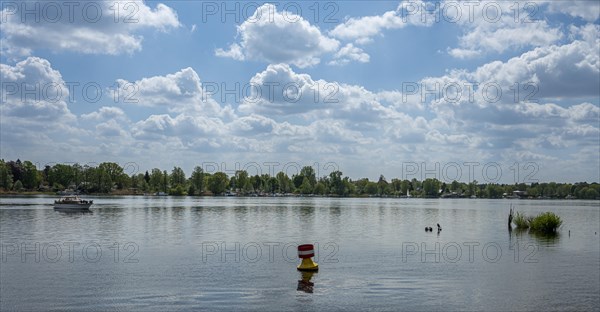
left=0, top=1, right=600, bottom=183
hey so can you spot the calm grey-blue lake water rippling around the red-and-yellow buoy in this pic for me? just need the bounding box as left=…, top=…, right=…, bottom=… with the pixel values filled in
left=0, top=196, right=600, bottom=311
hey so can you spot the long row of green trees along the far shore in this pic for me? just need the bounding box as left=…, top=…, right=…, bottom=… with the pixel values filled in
left=0, top=160, right=600, bottom=199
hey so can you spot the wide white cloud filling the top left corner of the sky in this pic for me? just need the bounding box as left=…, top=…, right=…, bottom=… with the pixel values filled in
left=0, top=0, right=180, bottom=56
